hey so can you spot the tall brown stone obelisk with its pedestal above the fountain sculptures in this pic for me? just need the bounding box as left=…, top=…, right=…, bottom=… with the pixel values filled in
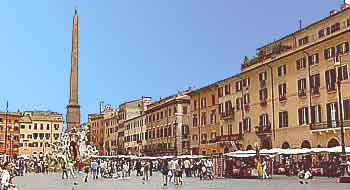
left=66, top=8, right=80, bottom=130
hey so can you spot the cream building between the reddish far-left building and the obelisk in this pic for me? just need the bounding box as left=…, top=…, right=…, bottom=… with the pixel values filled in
left=19, top=111, right=64, bottom=156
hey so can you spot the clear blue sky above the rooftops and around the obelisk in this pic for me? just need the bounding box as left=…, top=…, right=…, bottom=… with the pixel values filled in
left=0, top=0, right=342, bottom=121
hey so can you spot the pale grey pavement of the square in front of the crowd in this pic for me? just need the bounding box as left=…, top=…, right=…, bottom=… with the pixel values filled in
left=16, top=173, right=350, bottom=190
